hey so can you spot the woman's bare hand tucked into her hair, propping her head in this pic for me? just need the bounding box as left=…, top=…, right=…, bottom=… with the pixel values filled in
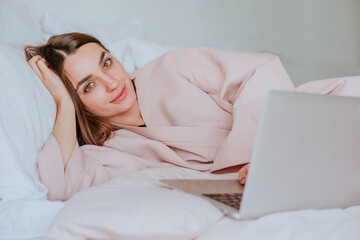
left=28, top=55, right=70, bottom=105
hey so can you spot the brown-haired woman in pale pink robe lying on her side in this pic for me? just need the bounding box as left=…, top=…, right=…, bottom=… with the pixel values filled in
left=25, top=33, right=294, bottom=200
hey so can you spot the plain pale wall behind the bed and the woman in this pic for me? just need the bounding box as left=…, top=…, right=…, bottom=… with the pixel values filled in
left=44, top=0, right=360, bottom=85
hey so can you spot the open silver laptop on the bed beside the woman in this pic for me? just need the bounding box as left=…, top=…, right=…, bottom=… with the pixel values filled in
left=161, top=91, right=360, bottom=219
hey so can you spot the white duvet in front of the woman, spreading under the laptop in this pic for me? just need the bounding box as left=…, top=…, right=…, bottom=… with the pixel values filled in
left=40, top=168, right=360, bottom=240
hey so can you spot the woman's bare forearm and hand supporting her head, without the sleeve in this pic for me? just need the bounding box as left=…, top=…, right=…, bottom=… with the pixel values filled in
left=29, top=56, right=76, bottom=170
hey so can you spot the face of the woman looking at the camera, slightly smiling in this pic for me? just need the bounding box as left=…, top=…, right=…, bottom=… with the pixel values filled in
left=64, top=43, right=137, bottom=123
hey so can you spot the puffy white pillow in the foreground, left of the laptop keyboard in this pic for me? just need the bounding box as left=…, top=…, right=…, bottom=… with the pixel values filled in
left=45, top=168, right=223, bottom=240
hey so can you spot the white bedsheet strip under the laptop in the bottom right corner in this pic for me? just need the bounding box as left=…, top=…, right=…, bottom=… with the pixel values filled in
left=198, top=206, right=360, bottom=240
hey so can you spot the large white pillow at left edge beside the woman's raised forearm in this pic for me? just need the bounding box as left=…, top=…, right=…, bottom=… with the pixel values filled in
left=0, top=42, right=56, bottom=202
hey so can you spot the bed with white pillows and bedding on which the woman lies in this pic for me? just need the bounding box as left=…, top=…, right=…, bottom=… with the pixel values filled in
left=0, top=0, right=360, bottom=240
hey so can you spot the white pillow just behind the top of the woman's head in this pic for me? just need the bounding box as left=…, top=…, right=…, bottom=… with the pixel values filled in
left=40, top=12, right=145, bottom=47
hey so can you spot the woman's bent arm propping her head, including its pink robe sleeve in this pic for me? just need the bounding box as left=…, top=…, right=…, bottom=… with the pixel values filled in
left=29, top=56, right=149, bottom=200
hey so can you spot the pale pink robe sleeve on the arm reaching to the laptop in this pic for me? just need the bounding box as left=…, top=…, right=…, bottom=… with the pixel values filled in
left=161, top=48, right=294, bottom=172
